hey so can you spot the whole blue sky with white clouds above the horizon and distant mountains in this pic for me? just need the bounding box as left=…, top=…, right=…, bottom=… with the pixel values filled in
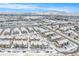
left=0, top=3, right=79, bottom=13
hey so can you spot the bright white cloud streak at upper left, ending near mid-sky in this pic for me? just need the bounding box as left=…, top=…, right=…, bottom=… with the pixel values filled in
left=0, top=4, right=38, bottom=9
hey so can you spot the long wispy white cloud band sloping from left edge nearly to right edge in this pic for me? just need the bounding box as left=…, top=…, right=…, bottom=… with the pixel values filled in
left=0, top=3, right=72, bottom=12
